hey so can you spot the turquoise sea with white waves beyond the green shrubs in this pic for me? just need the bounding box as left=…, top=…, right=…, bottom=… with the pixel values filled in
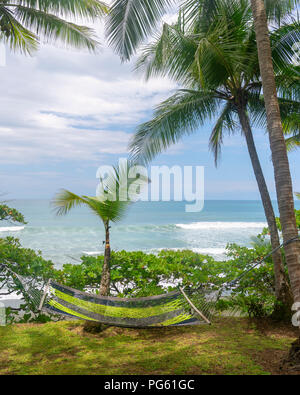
left=0, top=200, right=300, bottom=267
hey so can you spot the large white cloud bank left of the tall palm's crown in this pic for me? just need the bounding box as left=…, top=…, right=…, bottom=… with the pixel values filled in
left=0, top=29, right=174, bottom=164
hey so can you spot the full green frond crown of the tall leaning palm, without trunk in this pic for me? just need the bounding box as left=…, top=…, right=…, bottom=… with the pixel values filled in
left=129, top=0, right=299, bottom=169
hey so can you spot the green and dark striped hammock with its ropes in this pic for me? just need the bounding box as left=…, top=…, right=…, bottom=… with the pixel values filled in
left=0, top=236, right=300, bottom=328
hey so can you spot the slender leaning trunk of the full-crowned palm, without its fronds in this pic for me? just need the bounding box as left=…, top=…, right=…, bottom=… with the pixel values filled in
left=238, top=103, right=293, bottom=312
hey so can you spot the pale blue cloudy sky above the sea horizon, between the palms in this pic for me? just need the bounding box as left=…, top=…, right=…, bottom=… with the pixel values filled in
left=0, top=14, right=300, bottom=200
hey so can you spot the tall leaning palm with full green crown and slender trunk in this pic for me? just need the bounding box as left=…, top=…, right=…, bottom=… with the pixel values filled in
left=130, top=0, right=300, bottom=306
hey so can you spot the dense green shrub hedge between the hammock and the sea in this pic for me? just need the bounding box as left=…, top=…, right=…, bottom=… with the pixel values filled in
left=0, top=207, right=300, bottom=322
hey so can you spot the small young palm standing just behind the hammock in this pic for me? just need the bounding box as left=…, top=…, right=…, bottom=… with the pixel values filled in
left=52, top=162, right=147, bottom=295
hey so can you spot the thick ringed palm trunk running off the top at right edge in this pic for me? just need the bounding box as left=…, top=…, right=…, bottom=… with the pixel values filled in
left=251, top=0, right=300, bottom=332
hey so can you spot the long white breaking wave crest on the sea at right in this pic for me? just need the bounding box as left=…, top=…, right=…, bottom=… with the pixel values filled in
left=176, top=222, right=267, bottom=230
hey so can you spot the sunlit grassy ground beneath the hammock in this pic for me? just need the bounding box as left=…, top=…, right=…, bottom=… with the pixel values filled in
left=0, top=318, right=300, bottom=375
